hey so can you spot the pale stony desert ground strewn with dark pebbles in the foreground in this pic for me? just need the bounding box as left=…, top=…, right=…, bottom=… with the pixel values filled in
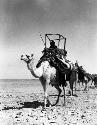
left=0, top=81, right=97, bottom=125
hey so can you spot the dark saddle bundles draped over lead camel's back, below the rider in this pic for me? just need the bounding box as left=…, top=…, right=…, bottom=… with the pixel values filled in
left=36, top=49, right=71, bottom=74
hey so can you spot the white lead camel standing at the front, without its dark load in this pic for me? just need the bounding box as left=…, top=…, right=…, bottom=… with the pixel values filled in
left=21, top=54, right=65, bottom=108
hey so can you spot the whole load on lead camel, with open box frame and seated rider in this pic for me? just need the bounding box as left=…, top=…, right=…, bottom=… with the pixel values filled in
left=36, top=34, right=71, bottom=74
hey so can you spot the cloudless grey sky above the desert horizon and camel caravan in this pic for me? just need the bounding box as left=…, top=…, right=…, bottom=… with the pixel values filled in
left=0, top=0, right=97, bottom=79
